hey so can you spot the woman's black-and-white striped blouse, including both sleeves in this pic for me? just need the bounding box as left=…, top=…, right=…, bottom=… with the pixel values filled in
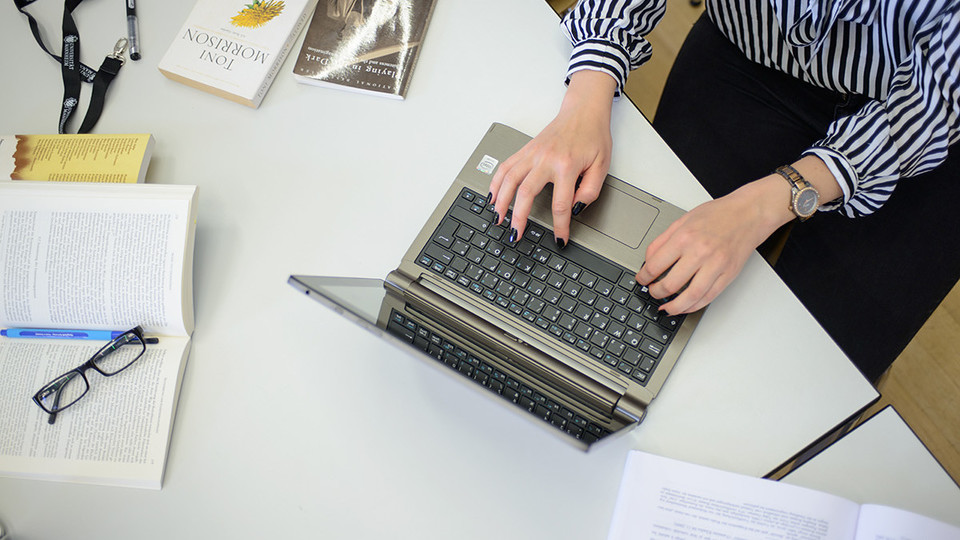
left=562, top=0, right=960, bottom=217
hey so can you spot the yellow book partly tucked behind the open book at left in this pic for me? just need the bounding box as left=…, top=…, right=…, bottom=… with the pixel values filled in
left=0, top=133, right=154, bottom=183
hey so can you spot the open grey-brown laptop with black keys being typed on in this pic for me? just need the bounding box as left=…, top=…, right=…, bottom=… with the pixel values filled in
left=289, top=124, right=700, bottom=449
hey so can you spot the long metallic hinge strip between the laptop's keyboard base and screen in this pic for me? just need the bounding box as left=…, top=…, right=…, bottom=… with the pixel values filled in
left=384, top=272, right=628, bottom=419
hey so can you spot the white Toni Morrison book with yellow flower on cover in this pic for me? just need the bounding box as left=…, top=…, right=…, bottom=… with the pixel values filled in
left=159, top=0, right=317, bottom=108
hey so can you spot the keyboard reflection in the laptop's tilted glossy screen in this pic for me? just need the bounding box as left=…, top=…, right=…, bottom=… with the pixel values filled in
left=387, top=309, right=610, bottom=444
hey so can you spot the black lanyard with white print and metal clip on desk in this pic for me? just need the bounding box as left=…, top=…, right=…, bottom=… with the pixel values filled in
left=13, top=0, right=127, bottom=133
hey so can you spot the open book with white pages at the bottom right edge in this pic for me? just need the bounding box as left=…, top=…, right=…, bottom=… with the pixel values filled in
left=608, top=451, right=960, bottom=540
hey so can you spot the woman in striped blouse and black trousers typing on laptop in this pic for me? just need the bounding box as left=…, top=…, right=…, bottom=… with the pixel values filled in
left=490, top=0, right=960, bottom=380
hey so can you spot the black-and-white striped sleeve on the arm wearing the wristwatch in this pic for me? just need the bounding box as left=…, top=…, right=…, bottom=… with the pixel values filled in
left=807, top=7, right=960, bottom=217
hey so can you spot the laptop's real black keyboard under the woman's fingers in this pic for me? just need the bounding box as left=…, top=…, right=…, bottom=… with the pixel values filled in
left=417, top=188, right=684, bottom=385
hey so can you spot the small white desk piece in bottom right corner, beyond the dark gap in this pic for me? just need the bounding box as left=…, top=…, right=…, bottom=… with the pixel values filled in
left=781, top=407, right=960, bottom=526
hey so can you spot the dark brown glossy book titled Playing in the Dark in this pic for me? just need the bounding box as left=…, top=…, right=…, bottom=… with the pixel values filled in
left=293, top=0, right=436, bottom=99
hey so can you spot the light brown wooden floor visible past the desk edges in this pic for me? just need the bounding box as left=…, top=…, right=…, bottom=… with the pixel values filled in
left=548, top=0, right=960, bottom=483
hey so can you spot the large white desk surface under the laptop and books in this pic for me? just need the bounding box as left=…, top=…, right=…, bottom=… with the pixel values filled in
left=0, top=0, right=877, bottom=540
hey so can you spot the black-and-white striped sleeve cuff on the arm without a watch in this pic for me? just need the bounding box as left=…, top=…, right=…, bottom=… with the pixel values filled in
left=561, top=0, right=666, bottom=96
